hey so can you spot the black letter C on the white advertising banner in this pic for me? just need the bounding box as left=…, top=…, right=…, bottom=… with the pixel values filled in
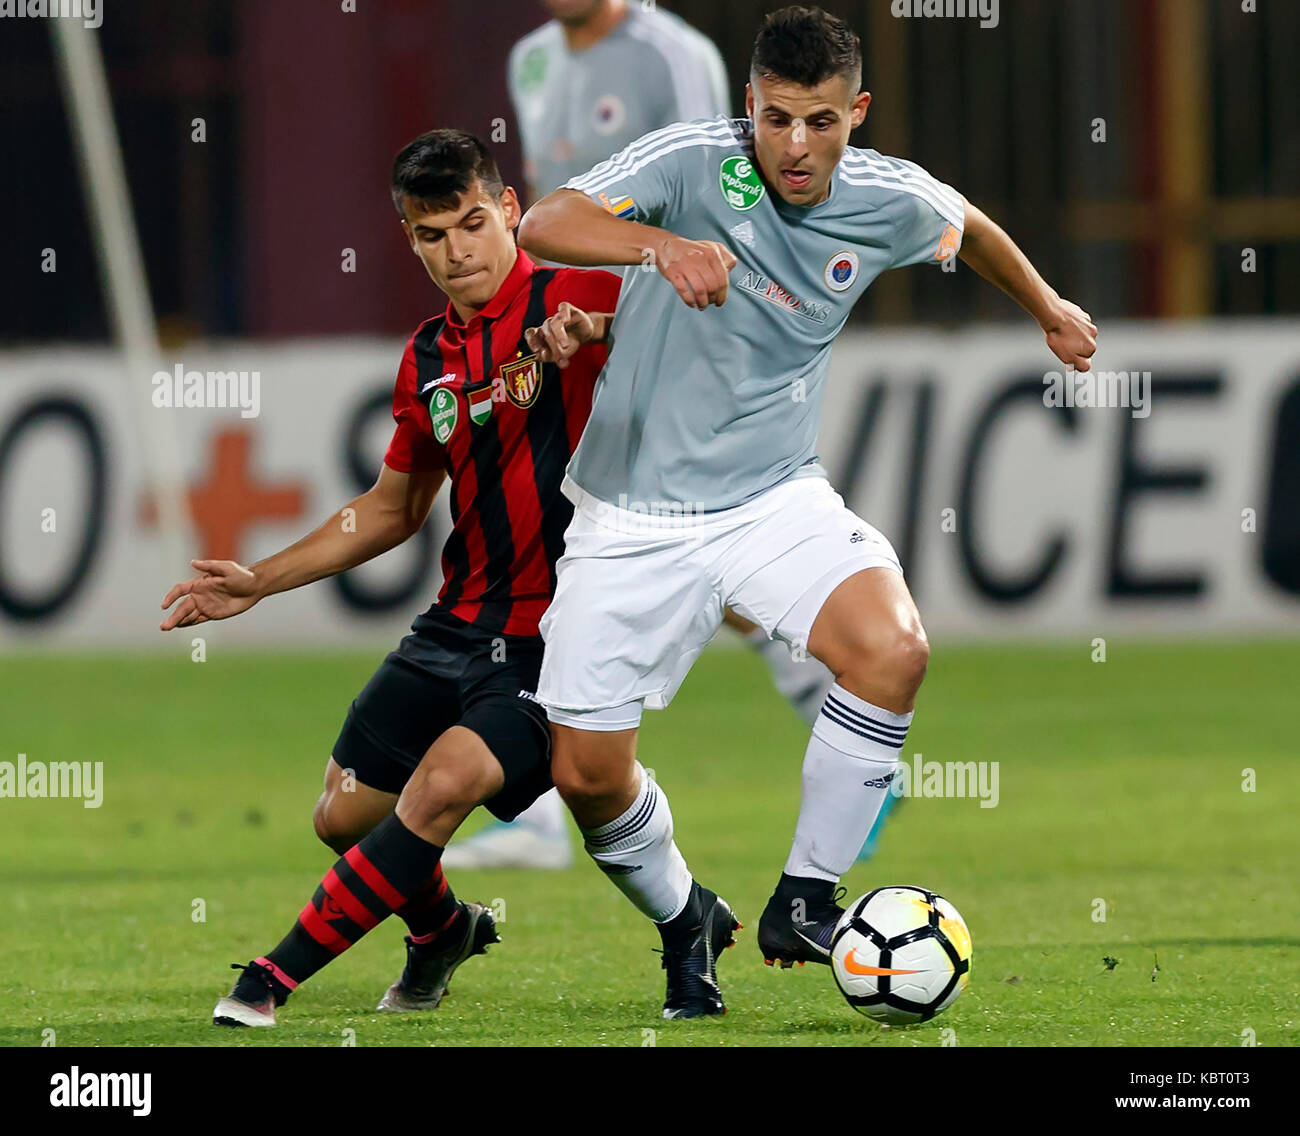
left=957, top=376, right=1079, bottom=603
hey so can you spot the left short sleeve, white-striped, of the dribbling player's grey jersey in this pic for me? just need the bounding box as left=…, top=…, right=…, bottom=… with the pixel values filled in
left=564, top=123, right=707, bottom=225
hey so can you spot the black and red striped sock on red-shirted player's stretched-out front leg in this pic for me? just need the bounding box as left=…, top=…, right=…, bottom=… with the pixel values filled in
left=256, top=814, right=450, bottom=994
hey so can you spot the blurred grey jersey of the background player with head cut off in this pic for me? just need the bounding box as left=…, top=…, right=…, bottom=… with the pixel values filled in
left=507, top=4, right=728, bottom=196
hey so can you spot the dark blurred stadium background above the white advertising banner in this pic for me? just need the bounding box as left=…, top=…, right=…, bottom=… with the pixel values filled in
left=0, top=0, right=1300, bottom=342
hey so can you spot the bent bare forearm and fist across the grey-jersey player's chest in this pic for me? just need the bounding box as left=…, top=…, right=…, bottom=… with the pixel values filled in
left=519, top=190, right=736, bottom=311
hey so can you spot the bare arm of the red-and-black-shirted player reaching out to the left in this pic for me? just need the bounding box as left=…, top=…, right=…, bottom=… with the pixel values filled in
left=159, top=465, right=447, bottom=632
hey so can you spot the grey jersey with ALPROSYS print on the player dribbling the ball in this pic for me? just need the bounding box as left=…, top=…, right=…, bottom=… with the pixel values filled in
left=567, top=118, right=965, bottom=511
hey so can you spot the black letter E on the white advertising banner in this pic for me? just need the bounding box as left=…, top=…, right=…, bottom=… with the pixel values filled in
left=1106, top=374, right=1223, bottom=599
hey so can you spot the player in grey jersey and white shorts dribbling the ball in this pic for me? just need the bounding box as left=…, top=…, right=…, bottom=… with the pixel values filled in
left=520, top=8, right=1096, bottom=1016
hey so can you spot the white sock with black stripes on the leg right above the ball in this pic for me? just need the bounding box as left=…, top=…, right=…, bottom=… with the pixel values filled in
left=785, top=682, right=911, bottom=880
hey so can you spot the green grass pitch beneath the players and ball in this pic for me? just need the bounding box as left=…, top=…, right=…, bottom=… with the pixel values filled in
left=0, top=639, right=1300, bottom=1046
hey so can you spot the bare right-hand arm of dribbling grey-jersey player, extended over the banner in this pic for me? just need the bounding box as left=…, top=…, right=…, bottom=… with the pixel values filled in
left=958, top=198, right=1097, bottom=370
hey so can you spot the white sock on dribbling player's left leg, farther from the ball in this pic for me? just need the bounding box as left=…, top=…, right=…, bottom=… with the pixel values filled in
left=582, top=762, right=692, bottom=923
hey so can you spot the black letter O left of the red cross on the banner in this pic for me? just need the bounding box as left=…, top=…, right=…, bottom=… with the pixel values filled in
left=0, top=395, right=108, bottom=621
